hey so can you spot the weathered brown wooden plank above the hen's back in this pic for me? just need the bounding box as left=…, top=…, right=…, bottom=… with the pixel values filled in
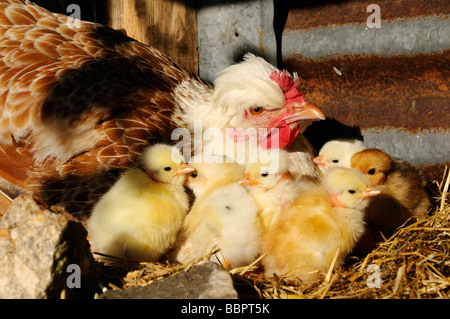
left=104, top=0, right=198, bottom=73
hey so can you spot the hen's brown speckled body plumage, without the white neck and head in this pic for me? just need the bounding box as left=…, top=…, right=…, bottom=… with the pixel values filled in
left=0, top=0, right=206, bottom=221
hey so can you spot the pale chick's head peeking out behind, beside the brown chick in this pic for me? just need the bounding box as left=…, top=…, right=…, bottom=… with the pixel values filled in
left=313, top=140, right=366, bottom=172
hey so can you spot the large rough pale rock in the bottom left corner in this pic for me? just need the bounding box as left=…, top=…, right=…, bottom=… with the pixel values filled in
left=0, top=194, right=99, bottom=299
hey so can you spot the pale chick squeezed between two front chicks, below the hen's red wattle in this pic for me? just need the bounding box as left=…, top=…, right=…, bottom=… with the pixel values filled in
left=239, top=150, right=312, bottom=231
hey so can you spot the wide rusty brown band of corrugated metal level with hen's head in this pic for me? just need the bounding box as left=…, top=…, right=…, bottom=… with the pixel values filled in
left=284, top=51, right=450, bottom=133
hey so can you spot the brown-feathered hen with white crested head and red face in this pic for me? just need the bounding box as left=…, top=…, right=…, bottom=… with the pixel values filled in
left=0, top=0, right=324, bottom=222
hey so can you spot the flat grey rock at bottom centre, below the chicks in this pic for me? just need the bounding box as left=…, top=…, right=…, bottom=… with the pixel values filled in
left=99, top=262, right=238, bottom=299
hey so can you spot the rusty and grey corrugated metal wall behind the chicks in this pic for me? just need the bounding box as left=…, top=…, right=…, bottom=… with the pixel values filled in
left=275, top=0, right=450, bottom=178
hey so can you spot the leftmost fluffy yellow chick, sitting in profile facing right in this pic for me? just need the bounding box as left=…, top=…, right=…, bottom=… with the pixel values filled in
left=87, top=144, right=192, bottom=261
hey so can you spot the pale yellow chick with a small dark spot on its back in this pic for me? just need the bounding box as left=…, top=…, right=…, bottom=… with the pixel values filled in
left=175, top=157, right=260, bottom=268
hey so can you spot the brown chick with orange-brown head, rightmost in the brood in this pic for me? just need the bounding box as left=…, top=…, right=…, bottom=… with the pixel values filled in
left=350, top=148, right=430, bottom=257
